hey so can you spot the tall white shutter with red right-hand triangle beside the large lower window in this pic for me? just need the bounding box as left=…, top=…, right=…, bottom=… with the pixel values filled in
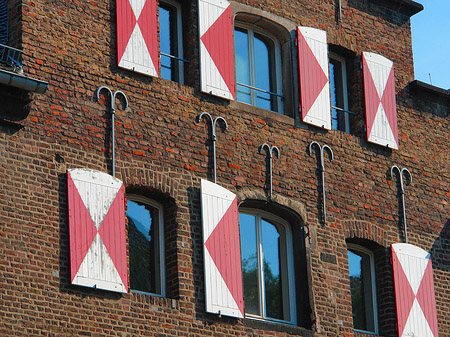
left=201, top=180, right=244, bottom=317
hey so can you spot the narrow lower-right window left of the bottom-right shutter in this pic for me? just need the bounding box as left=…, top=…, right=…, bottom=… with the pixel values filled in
left=347, top=243, right=378, bottom=333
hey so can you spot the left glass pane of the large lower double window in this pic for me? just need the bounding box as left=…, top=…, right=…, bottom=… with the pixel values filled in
left=239, top=214, right=260, bottom=315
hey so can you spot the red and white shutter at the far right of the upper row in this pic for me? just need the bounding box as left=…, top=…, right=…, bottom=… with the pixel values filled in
left=362, top=52, right=398, bottom=149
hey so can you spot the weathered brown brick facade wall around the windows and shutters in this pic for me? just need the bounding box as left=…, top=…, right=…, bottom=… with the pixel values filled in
left=0, top=0, right=450, bottom=336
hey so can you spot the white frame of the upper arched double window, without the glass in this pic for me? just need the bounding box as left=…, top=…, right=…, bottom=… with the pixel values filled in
left=233, top=21, right=284, bottom=114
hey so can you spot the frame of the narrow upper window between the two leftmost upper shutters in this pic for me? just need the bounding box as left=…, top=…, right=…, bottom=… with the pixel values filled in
left=158, top=0, right=188, bottom=84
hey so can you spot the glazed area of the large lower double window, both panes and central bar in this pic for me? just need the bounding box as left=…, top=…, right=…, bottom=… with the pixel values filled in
left=239, top=213, right=287, bottom=320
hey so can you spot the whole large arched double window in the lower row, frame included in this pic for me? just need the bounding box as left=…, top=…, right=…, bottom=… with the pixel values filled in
left=239, top=209, right=296, bottom=324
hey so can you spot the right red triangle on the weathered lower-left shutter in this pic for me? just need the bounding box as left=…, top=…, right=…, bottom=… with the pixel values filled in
left=98, top=185, right=128, bottom=289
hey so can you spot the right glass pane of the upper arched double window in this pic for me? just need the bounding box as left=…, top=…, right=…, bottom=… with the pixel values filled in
left=254, top=34, right=274, bottom=110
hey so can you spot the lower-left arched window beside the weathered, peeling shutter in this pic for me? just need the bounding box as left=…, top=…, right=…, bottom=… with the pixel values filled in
left=127, top=195, right=165, bottom=296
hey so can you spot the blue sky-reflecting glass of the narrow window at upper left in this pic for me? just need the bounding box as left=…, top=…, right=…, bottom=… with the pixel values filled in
left=159, top=7, right=174, bottom=80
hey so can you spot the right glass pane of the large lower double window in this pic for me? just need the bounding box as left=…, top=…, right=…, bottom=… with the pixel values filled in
left=261, top=220, right=283, bottom=319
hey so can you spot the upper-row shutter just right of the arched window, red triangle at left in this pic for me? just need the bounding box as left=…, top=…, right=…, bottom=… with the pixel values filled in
left=297, top=27, right=331, bottom=130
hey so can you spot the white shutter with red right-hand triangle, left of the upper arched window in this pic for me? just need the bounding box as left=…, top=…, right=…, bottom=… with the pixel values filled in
left=198, top=0, right=236, bottom=99
